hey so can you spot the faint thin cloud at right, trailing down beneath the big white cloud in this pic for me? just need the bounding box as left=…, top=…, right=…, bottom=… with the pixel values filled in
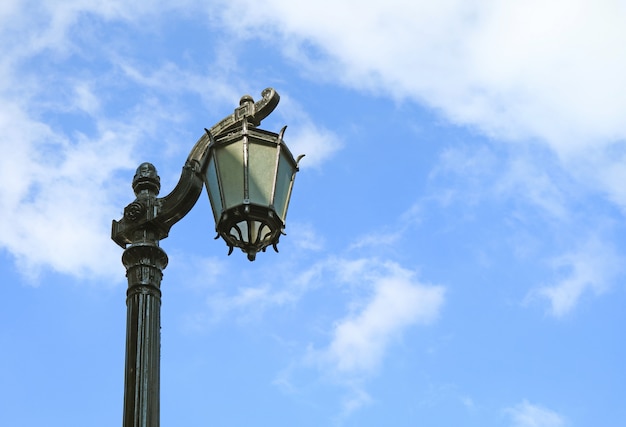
left=424, top=142, right=626, bottom=317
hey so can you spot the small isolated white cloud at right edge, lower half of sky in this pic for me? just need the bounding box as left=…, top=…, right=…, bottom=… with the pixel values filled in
left=527, top=237, right=623, bottom=317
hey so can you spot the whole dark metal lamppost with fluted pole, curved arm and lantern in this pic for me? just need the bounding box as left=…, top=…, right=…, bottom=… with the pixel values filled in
left=111, top=88, right=302, bottom=427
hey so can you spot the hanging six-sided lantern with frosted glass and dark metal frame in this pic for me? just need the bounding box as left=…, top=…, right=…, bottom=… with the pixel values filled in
left=203, top=119, right=302, bottom=261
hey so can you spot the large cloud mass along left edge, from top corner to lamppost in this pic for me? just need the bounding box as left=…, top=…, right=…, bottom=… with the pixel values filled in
left=0, top=2, right=183, bottom=282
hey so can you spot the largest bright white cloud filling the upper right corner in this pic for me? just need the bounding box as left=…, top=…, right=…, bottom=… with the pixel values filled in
left=216, top=0, right=626, bottom=152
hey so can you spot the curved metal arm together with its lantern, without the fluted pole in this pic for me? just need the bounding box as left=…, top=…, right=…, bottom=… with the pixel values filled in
left=112, top=88, right=304, bottom=261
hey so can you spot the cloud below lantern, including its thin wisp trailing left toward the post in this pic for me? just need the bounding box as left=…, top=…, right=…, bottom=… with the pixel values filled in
left=179, top=257, right=445, bottom=416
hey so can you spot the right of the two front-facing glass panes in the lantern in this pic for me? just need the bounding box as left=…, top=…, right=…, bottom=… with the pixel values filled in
left=248, top=138, right=277, bottom=206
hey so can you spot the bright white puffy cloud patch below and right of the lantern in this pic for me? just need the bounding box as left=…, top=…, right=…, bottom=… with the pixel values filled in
left=288, top=258, right=445, bottom=417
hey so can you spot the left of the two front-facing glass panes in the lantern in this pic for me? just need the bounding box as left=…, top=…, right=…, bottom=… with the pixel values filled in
left=214, top=139, right=244, bottom=209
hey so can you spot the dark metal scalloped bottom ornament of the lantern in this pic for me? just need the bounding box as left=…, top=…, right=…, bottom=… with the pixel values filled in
left=215, top=204, right=285, bottom=261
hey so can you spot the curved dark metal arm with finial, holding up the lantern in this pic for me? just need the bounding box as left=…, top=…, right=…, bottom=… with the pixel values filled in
left=111, top=88, right=280, bottom=248
